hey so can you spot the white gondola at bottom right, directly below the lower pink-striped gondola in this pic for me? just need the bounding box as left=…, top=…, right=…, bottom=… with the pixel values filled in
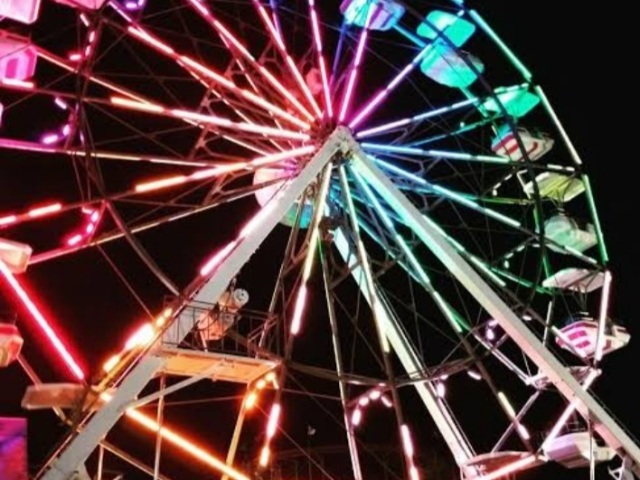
left=544, top=432, right=616, bottom=468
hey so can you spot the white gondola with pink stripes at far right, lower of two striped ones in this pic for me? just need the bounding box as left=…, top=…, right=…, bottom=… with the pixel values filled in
left=556, top=316, right=631, bottom=358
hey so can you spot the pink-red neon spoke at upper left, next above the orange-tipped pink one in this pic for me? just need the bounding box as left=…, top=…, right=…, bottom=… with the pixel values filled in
left=127, top=26, right=310, bottom=130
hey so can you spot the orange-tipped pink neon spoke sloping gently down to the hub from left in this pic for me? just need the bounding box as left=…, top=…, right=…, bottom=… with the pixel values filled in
left=110, top=97, right=309, bottom=140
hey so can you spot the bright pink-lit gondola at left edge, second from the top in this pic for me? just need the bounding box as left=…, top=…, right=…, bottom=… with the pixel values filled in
left=0, top=30, right=38, bottom=80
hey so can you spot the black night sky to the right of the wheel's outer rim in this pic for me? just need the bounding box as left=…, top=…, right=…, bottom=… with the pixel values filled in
left=0, top=0, right=640, bottom=479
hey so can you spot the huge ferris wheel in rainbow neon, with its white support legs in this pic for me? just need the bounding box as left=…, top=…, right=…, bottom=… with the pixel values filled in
left=0, top=0, right=640, bottom=480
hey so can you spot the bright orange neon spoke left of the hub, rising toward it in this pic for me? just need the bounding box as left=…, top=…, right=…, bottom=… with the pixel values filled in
left=135, top=145, right=315, bottom=193
